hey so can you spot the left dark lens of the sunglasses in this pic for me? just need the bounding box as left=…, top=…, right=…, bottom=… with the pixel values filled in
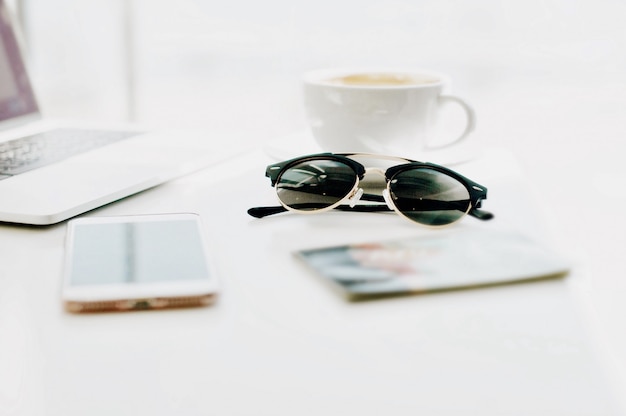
left=276, top=159, right=357, bottom=211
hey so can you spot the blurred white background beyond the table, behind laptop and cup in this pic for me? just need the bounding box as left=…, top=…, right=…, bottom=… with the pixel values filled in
left=6, top=0, right=626, bottom=394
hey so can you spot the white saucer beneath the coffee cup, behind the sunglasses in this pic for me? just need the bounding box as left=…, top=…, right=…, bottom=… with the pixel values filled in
left=263, top=130, right=481, bottom=166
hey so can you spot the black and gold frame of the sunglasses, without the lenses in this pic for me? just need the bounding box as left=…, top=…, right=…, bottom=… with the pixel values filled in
left=248, top=152, right=493, bottom=227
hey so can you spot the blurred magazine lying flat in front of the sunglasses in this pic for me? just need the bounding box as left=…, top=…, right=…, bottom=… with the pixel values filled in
left=295, top=228, right=569, bottom=299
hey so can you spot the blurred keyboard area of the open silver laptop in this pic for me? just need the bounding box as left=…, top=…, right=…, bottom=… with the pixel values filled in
left=0, top=129, right=138, bottom=180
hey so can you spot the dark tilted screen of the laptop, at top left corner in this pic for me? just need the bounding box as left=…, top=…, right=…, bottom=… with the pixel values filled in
left=0, top=0, right=39, bottom=122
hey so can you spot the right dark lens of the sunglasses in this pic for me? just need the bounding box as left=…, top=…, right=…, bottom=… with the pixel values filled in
left=389, top=168, right=471, bottom=225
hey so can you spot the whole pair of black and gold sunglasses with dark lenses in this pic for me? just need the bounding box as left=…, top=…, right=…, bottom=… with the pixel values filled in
left=248, top=153, right=493, bottom=226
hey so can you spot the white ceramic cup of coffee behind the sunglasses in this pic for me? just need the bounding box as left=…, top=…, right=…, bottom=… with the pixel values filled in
left=303, top=68, right=476, bottom=155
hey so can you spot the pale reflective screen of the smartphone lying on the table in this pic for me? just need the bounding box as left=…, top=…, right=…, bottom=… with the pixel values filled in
left=70, top=216, right=209, bottom=286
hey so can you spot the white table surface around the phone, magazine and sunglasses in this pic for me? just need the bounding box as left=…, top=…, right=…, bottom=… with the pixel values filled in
left=0, top=139, right=624, bottom=416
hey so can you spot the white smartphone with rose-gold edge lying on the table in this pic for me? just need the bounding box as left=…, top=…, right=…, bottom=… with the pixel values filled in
left=62, top=213, right=217, bottom=312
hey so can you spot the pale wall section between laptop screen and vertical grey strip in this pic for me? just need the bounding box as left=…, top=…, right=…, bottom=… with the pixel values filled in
left=22, top=0, right=127, bottom=119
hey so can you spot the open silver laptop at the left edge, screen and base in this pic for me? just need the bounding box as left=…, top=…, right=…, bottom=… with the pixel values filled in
left=0, top=0, right=232, bottom=225
